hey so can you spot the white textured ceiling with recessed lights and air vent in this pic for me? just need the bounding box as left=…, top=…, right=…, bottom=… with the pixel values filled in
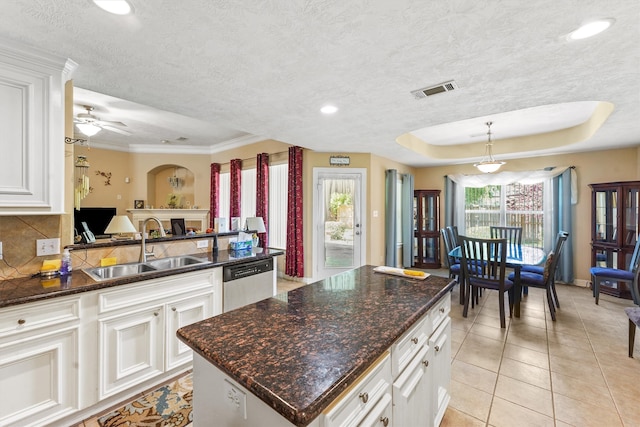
left=0, top=0, right=640, bottom=166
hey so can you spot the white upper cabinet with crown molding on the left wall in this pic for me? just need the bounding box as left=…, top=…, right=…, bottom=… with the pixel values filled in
left=0, top=39, right=77, bottom=215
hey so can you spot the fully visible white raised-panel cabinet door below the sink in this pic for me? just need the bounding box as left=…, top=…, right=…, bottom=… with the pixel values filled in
left=98, top=304, right=164, bottom=399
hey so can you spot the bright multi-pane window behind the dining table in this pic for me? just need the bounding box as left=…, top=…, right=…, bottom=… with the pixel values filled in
left=464, top=183, right=545, bottom=249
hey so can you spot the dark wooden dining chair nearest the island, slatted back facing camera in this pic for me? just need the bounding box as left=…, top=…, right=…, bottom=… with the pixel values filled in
left=459, top=236, right=514, bottom=328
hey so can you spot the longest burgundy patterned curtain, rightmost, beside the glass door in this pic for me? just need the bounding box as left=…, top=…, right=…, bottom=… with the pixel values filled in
left=285, top=147, right=304, bottom=277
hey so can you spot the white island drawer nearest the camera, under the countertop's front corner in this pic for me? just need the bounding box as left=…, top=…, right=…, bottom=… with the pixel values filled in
left=321, top=352, right=392, bottom=427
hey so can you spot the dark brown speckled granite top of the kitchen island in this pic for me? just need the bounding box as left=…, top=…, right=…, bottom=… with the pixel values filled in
left=178, top=266, right=453, bottom=426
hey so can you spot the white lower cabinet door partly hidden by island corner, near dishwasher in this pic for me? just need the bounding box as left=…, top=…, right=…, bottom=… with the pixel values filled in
left=165, top=292, right=213, bottom=371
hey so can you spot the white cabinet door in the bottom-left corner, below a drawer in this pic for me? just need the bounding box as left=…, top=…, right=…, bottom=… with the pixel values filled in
left=0, top=326, right=79, bottom=427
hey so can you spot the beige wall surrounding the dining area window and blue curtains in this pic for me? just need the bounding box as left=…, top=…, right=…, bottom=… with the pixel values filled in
left=415, top=148, right=640, bottom=284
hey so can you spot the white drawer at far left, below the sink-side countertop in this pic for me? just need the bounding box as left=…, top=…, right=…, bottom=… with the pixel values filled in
left=0, top=297, right=80, bottom=337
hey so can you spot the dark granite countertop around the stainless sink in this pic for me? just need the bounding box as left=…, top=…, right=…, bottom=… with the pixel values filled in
left=0, top=249, right=283, bottom=309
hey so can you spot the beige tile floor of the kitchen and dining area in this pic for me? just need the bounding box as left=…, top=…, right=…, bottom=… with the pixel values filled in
left=79, top=276, right=640, bottom=427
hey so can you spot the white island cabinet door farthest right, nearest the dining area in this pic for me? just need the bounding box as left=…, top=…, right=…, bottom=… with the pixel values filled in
left=429, top=317, right=451, bottom=426
